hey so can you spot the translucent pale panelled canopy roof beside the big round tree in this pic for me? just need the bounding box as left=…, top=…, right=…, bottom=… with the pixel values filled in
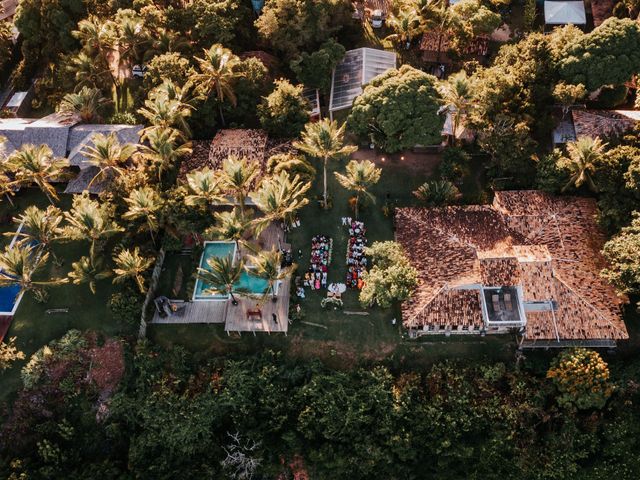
left=329, top=48, right=396, bottom=112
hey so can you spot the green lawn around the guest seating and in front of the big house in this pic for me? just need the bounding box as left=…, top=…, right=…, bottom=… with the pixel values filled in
left=149, top=152, right=515, bottom=367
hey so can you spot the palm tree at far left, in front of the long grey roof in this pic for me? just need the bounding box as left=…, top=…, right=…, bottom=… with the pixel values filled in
left=5, top=205, right=63, bottom=262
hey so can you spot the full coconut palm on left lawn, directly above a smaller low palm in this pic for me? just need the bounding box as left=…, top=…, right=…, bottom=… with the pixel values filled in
left=62, top=192, right=123, bottom=252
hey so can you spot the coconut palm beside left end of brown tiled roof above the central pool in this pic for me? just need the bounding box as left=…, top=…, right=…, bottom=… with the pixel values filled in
left=138, top=127, right=191, bottom=181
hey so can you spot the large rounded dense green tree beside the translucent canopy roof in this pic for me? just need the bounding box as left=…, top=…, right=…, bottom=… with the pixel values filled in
left=347, top=65, right=444, bottom=153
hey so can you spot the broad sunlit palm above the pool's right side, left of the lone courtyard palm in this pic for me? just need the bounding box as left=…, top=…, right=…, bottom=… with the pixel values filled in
left=249, top=171, right=311, bottom=234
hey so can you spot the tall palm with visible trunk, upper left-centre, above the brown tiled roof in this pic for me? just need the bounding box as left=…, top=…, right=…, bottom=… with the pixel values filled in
left=195, top=43, right=240, bottom=126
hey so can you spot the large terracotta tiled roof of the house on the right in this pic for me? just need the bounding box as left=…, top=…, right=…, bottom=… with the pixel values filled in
left=396, top=191, right=628, bottom=340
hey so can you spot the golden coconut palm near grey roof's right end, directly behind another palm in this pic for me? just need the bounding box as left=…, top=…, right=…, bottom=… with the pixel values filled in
left=138, top=80, right=193, bottom=139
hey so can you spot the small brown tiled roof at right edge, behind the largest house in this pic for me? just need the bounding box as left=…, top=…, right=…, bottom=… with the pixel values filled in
left=571, top=110, right=640, bottom=138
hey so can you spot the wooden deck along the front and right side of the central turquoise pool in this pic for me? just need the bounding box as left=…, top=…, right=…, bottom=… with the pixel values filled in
left=151, top=224, right=291, bottom=335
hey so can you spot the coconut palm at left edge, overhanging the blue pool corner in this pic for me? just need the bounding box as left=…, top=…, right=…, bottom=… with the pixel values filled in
left=0, top=243, right=68, bottom=295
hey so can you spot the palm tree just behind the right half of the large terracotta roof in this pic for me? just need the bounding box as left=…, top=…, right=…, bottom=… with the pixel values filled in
left=559, top=137, right=607, bottom=192
